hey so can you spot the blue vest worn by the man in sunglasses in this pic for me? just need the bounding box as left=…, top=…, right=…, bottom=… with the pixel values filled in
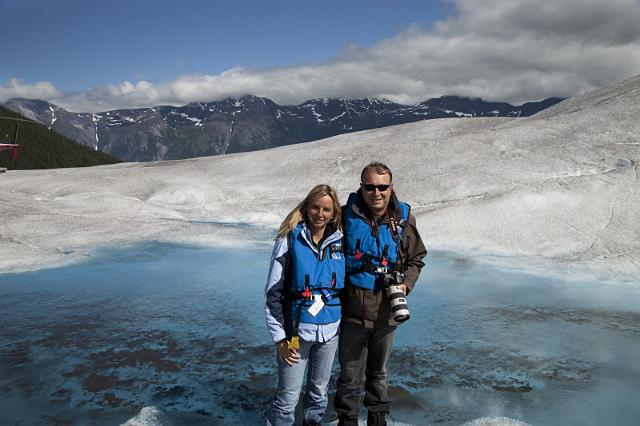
left=344, top=193, right=411, bottom=290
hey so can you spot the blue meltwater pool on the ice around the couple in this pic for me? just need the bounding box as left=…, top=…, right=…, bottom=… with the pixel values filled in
left=0, top=238, right=640, bottom=425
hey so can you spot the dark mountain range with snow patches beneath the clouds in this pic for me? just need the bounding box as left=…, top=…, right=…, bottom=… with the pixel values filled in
left=5, top=96, right=562, bottom=161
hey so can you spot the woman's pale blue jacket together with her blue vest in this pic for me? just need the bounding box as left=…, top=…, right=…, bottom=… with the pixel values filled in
left=265, top=222, right=345, bottom=342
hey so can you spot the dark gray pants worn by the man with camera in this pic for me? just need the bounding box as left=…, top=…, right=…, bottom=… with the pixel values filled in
left=333, top=320, right=396, bottom=418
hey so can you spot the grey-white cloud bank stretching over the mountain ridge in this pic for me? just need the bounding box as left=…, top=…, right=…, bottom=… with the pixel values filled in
left=0, top=0, right=640, bottom=112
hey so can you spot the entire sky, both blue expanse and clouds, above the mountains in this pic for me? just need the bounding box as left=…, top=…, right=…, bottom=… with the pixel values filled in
left=0, top=0, right=640, bottom=111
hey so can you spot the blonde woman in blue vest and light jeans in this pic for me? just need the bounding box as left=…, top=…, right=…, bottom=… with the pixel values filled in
left=265, top=185, right=344, bottom=426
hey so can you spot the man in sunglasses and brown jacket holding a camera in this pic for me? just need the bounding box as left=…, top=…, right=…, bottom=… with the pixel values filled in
left=334, top=162, right=427, bottom=426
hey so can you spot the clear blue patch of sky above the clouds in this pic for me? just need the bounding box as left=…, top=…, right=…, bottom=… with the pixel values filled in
left=0, top=0, right=450, bottom=91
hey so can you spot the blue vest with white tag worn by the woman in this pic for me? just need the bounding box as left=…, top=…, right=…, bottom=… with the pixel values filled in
left=289, top=223, right=345, bottom=324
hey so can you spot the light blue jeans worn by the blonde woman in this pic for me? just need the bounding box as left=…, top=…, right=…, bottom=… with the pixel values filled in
left=267, top=335, right=339, bottom=426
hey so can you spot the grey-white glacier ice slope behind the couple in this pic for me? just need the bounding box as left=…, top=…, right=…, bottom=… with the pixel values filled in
left=0, top=77, right=640, bottom=282
